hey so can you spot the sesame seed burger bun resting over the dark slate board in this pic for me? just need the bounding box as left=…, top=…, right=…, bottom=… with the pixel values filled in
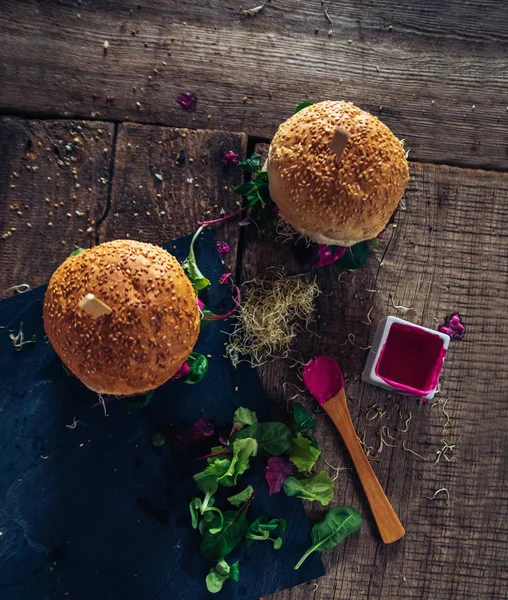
left=43, top=240, right=200, bottom=396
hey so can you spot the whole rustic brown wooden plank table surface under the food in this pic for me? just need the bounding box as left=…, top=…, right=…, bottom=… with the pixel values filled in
left=0, top=0, right=508, bottom=600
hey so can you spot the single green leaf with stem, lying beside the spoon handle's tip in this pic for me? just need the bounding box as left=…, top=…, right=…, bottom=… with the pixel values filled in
left=295, top=506, right=363, bottom=569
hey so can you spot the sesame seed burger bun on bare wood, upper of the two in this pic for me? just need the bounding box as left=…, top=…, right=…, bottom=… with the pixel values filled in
left=267, top=102, right=409, bottom=246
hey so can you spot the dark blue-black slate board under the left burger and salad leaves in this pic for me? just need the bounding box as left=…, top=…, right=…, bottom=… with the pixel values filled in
left=0, top=232, right=324, bottom=600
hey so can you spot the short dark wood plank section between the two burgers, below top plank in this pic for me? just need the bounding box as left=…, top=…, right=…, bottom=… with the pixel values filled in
left=99, top=123, right=247, bottom=269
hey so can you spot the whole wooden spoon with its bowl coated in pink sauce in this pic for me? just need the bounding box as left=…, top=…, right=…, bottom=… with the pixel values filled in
left=303, top=356, right=406, bottom=544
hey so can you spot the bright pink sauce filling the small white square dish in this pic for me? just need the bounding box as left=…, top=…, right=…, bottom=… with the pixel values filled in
left=376, top=323, right=446, bottom=396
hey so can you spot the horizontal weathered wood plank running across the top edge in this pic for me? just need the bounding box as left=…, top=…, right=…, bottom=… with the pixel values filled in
left=0, top=0, right=508, bottom=169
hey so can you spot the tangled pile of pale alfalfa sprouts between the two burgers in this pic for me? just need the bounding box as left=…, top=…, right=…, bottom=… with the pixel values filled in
left=226, top=271, right=319, bottom=367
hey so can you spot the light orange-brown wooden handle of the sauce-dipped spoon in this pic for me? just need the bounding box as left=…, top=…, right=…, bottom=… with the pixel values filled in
left=323, top=388, right=406, bottom=544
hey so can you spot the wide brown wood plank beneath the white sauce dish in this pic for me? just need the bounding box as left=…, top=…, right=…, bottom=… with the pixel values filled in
left=242, top=163, right=508, bottom=600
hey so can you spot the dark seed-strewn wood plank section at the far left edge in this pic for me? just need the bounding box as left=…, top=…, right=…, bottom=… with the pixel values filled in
left=0, top=118, right=115, bottom=295
